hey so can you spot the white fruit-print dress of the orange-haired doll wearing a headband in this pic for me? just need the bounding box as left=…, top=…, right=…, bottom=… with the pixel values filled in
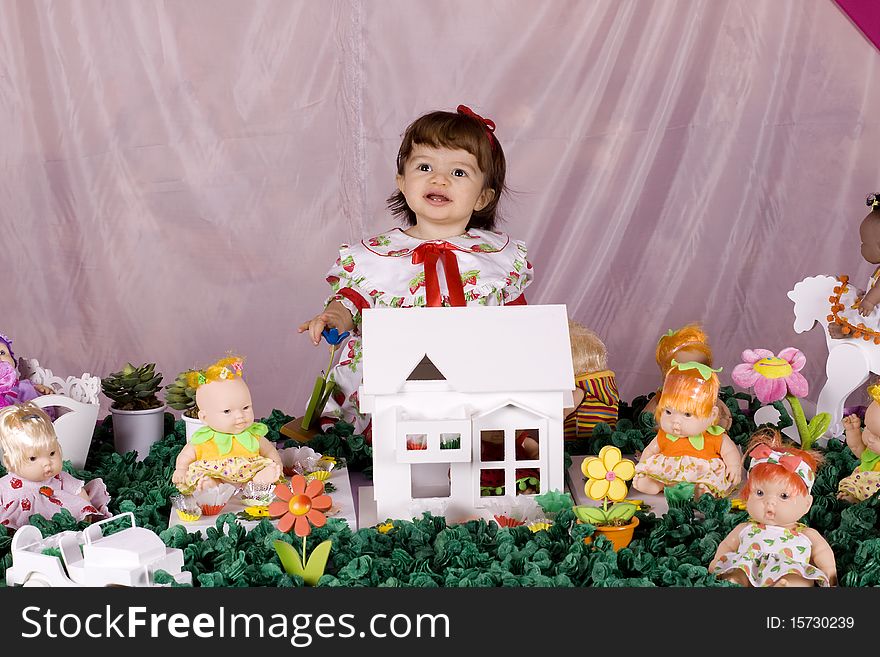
left=713, top=520, right=828, bottom=586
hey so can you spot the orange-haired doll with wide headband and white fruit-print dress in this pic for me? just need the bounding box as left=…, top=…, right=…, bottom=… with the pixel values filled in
left=709, top=429, right=837, bottom=586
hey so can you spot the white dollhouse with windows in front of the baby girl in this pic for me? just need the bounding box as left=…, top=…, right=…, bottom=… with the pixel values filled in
left=359, top=305, right=574, bottom=522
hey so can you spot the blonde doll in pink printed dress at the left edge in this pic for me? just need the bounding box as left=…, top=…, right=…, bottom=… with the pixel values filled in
left=0, top=402, right=110, bottom=529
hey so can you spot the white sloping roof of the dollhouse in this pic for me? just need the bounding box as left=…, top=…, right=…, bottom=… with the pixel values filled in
left=361, top=305, right=574, bottom=395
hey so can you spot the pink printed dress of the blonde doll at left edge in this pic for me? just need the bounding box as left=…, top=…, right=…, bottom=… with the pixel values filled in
left=0, top=471, right=110, bottom=529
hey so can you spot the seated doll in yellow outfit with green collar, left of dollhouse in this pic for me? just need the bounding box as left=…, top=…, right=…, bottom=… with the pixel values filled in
left=171, top=356, right=282, bottom=494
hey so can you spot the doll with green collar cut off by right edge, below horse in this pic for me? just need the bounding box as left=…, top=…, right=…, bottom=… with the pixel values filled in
left=837, top=384, right=880, bottom=502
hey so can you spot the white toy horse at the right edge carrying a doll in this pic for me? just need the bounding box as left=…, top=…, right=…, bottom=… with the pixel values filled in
left=788, top=275, right=880, bottom=437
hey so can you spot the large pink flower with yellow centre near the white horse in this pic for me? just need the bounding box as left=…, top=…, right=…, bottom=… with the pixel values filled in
left=730, top=347, right=810, bottom=404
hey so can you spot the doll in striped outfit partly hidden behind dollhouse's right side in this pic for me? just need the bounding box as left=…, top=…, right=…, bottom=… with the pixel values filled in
left=564, top=319, right=620, bottom=443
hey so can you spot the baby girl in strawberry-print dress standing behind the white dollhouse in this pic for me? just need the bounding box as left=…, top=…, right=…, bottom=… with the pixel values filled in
left=299, top=105, right=532, bottom=433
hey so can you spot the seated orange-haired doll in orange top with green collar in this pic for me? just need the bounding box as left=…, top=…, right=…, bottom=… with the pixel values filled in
left=633, top=359, right=742, bottom=497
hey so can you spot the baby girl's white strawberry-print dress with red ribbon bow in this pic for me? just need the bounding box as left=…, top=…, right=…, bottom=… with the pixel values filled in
left=324, top=228, right=533, bottom=433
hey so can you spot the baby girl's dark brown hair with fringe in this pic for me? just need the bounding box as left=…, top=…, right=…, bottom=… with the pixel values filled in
left=388, top=106, right=507, bottom=230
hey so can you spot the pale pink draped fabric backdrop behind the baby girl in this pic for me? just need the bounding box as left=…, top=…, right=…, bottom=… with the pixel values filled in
left=0, top=0, right=880, bottom=415
